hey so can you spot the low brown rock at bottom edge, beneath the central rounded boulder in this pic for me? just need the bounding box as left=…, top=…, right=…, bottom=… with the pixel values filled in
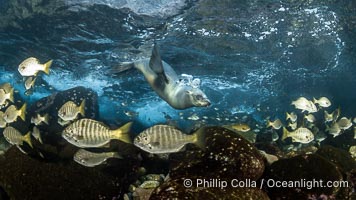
left=150, top=177, right=269, bottom=200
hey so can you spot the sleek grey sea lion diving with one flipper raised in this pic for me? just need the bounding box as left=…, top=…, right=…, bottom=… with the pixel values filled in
left=114, top=45, right=210, bottom=109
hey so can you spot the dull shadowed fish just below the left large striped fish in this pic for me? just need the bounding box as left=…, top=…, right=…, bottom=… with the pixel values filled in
left=73, top=149, right=122, bottom=167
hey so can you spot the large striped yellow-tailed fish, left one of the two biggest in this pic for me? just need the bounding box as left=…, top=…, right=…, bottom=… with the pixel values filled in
left=62, top=119, right=132, bottom=148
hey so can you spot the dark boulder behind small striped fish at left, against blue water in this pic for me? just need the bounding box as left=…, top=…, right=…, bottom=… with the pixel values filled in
left=23, top=87, right=99, bottom=161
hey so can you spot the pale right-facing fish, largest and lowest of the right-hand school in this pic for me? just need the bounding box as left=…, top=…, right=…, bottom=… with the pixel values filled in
left=282, top=127, right=314, bottom=144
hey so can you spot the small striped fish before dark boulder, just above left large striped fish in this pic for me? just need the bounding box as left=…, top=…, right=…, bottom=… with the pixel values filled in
left=58, top=99, right=85, bottom=121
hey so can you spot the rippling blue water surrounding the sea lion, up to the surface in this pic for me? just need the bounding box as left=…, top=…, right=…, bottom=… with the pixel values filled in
left=0, top=0, right=356, bottom=129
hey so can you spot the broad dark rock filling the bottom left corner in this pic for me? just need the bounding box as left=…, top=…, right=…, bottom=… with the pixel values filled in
left=0, top=147, right=136, bottom=199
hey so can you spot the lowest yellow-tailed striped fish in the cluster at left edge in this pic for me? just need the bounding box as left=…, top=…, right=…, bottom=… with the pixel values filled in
left=3, top=126, right=33, bottom=148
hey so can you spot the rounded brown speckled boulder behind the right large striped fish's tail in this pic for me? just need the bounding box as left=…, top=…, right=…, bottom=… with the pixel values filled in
left=170, top=127, right=265, bottom=180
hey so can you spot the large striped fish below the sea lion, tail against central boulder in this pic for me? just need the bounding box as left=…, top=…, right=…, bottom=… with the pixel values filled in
left=134, top=125, right=205, bottom=154
